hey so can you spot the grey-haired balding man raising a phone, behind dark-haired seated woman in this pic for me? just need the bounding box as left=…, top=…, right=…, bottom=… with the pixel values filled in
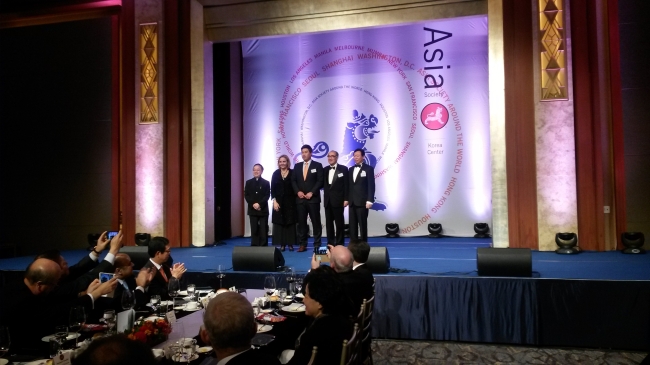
left=311, top=246, right=373, bottom=316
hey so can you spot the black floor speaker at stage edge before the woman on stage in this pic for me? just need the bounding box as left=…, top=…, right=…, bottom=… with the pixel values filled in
left=232, top=246, right=284, bottom=271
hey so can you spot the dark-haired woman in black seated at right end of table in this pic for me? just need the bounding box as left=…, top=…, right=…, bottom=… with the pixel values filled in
left=288, top=266, right=352, bottom=365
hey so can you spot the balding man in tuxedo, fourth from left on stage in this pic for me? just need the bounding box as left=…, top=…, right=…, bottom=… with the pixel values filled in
left=323, top=151, right=349, bottom=246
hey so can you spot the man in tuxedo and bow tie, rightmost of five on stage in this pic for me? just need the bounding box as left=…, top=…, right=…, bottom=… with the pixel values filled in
left=348, top=148, right=375, bottom=242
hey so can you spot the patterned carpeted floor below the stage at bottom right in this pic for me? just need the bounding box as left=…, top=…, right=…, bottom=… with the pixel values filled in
left=372, top=340, right=647, bottom=365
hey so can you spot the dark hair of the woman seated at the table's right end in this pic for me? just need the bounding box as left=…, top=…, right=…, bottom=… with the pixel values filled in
left=303, top=265, right=352, bottom=315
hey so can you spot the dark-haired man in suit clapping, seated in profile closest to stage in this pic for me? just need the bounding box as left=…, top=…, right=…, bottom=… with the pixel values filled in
left=142, top=237, right=187, bottom=300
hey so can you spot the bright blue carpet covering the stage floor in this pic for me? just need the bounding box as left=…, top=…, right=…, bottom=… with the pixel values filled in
left=0, top=237, right=650, bottom=280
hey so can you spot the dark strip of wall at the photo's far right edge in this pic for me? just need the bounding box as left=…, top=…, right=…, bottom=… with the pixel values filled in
left=618, top=0, right=650, bottom=239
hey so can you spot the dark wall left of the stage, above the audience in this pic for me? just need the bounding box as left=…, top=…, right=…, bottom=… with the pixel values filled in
left=0, top=18, right=111, bottom=254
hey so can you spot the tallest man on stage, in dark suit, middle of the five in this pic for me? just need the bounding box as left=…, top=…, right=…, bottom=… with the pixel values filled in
left=291, top=144, right=323, bottom=252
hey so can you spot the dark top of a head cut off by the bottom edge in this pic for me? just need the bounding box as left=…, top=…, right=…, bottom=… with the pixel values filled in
left=72, top=335, right=156, bottom=365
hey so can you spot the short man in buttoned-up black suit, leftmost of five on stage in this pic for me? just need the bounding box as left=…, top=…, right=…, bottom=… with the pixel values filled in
left=244, top=163, right=271, bottom=246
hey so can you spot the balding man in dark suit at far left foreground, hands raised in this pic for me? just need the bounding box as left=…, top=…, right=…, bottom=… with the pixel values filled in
left=0, top=259, right=117, bottom=354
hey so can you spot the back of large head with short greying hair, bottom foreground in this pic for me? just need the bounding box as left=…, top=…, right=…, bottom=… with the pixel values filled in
left=202, top=292, right=257, bottom=351
